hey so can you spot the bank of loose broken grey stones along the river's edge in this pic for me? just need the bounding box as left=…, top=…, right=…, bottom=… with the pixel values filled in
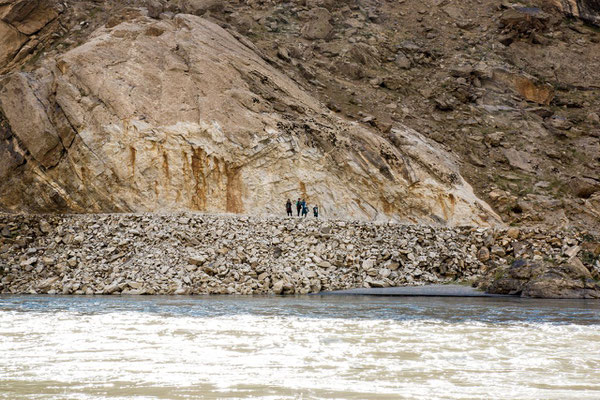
left=0, top=213, right=600, bottom=297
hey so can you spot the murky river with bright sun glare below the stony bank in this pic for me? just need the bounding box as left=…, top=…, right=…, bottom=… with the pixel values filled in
left=0, top=296, right=600, bottom=400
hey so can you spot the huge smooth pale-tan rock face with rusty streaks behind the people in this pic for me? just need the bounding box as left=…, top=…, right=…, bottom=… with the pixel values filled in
left=0, top=15, right=499, bottom=224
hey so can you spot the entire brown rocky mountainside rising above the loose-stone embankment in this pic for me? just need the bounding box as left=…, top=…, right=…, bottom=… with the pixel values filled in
left=0, top=0, right=600, bottom=229
